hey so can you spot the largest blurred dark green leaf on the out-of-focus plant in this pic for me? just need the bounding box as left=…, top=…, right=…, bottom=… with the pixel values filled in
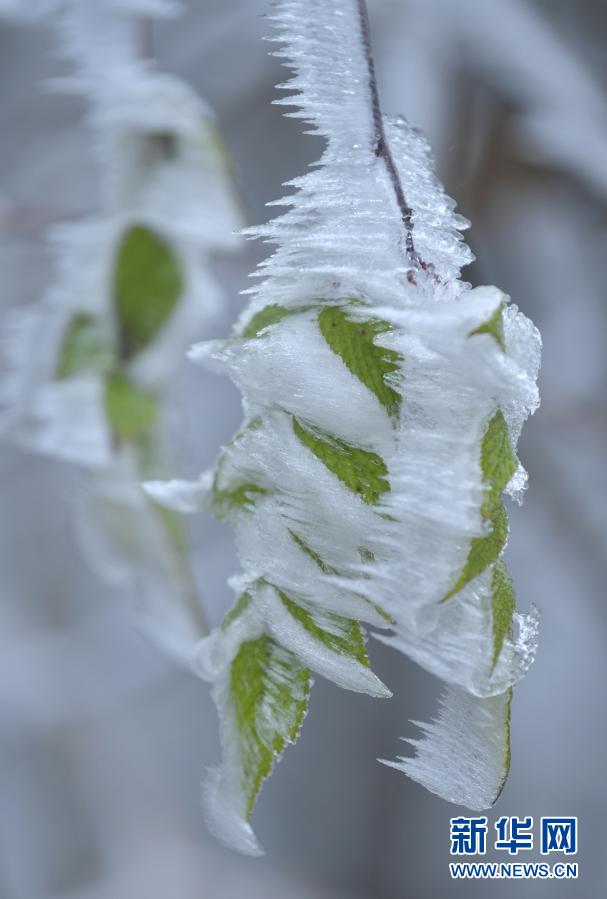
left=114, top=225, right=183, bottom=360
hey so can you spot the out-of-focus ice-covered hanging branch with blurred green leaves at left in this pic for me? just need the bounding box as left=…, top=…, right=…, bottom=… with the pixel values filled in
left=2, top=0, right=239, bottom=660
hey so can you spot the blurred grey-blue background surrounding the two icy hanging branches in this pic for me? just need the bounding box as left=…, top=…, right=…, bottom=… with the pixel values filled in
left=0, top=0, right=607, bottom=899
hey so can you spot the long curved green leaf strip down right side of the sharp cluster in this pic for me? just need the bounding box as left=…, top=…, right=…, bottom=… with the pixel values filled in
left=445, top=409, right=518, bottom=599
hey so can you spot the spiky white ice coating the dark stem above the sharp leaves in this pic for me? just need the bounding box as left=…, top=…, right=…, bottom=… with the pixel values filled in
left=243, top=0, right=473, bottom=320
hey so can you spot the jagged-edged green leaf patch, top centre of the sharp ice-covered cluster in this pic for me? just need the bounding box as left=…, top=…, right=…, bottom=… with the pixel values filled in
left=318, top=306, right=401, bottom=415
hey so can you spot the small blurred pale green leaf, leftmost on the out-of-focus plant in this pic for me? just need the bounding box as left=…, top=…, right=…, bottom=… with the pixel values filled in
left=55, top=312, right=114, bottom=378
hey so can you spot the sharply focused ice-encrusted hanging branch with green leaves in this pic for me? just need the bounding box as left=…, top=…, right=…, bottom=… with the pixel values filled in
left=149, top=0, right=540, bottom=854
